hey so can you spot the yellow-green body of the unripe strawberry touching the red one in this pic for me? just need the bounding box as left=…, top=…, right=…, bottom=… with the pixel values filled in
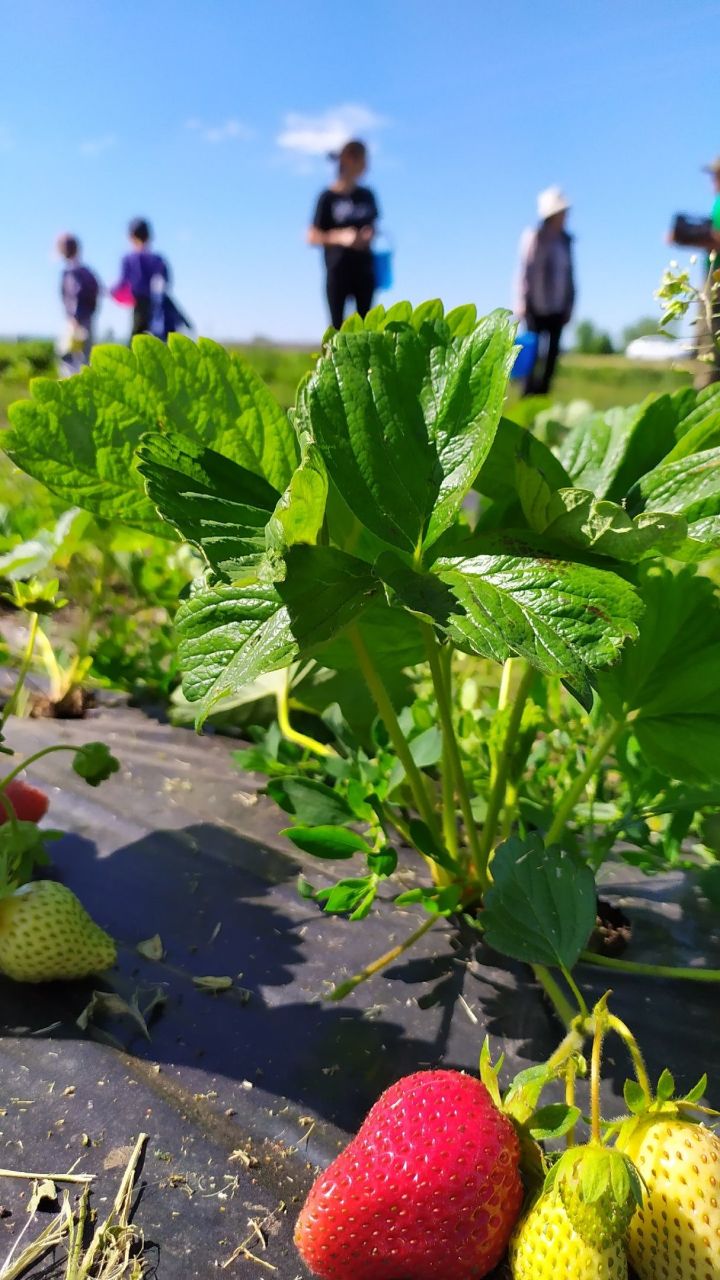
left=510, top=1187, right=628, bottom=1280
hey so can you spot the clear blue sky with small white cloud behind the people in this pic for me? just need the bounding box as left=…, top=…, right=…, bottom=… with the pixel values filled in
left=0, top=0, right=720, bottom=340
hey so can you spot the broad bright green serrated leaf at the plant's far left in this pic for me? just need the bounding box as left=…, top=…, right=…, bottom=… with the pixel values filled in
left=3, top=334, right=299, bottom=538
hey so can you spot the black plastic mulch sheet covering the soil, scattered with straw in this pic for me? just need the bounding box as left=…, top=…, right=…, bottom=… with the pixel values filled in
left=0, top=708, right=720, bottom=1280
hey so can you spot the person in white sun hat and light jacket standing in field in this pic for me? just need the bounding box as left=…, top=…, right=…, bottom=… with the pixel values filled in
left=516, top=187, right=575, bottom=396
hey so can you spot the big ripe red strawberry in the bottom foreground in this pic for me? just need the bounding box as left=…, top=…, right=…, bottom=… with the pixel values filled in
left=295, top=1071, right=523, bottom=1280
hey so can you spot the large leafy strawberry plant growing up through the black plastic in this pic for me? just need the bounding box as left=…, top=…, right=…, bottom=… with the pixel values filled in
left=5, top=302, right=720, bottom=1011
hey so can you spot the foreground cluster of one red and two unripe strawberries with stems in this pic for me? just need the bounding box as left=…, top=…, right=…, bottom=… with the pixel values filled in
left=289, top=996, right=720, bottom=1280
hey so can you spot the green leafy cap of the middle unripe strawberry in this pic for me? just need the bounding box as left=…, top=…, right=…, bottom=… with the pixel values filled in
left=547, top=1143, right=643, bottom=1248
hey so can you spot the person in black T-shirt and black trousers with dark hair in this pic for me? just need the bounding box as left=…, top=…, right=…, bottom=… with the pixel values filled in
left=307, top=140, right=379, bottom=329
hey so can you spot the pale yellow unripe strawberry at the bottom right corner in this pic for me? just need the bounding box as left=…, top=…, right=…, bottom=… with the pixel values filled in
left=609, top=1071, right=720, bottom=1280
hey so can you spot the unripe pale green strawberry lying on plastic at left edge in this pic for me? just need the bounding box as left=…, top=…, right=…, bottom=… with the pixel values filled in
left=0, top=881, right=117, bottom=982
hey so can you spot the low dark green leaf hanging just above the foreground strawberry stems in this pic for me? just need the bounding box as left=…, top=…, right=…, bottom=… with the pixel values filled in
left=483, top=836, right=597, bottom=969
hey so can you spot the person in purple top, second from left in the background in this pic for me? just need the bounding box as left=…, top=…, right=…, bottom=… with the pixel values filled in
left=110, top=218, right=192, bottom=342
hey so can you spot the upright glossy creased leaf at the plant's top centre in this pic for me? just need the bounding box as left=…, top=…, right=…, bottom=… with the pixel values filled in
left=299, top=311, right=512, bottom=552
